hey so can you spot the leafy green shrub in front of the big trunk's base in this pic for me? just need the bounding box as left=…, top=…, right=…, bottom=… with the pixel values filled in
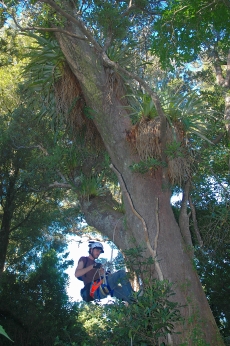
left=120, top=279, right=181, bottom=345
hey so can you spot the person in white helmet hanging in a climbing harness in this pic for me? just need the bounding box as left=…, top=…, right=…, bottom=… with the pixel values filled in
left=75, top=242, right=134, bottom=303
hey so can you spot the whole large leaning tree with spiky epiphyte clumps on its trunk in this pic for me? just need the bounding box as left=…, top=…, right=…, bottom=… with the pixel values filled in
left=2, top=0, right=228, bottom=345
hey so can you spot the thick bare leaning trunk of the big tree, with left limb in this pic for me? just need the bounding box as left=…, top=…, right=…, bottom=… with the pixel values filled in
left=54, top=23, right=222, bottom=346
